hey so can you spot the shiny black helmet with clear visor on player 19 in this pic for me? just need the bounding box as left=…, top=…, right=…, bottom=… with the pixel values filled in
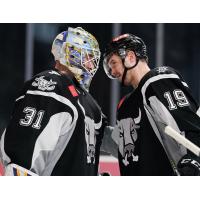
left=103, top=34, right=148, bottom=79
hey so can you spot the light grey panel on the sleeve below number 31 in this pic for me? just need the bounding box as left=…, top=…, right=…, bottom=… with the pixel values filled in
left=31, top=112, right=75, bottom=175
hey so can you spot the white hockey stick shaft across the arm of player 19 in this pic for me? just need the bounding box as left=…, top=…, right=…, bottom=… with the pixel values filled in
left=145, top=105, right=200, bottom=156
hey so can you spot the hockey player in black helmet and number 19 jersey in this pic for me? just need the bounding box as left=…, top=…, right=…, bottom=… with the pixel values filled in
left=104, top=34, right=200, bottom=175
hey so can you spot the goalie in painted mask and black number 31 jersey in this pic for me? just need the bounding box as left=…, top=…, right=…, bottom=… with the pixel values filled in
left=1, top=27, right=103, bottom=175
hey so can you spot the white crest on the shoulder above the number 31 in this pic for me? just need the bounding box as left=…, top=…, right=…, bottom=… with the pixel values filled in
left=32, top=76, right=57, bottom=91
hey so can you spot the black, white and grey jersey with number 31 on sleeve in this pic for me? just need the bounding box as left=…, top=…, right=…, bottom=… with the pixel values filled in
left=1, top=70, right=103, bottom=175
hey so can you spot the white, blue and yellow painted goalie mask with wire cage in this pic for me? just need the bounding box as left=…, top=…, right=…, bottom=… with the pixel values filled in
left=51, top=27, right=100, bottom=90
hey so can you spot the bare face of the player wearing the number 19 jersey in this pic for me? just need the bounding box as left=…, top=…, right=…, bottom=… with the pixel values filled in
left=108, top=54, right=124, bottom=81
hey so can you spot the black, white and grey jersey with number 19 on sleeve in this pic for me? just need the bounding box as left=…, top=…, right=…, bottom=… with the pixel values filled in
left=115, top=67, right=200, bottom=175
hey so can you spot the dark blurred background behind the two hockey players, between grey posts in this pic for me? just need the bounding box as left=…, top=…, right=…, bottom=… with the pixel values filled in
left=0, top=23, right=200, bottom=133
